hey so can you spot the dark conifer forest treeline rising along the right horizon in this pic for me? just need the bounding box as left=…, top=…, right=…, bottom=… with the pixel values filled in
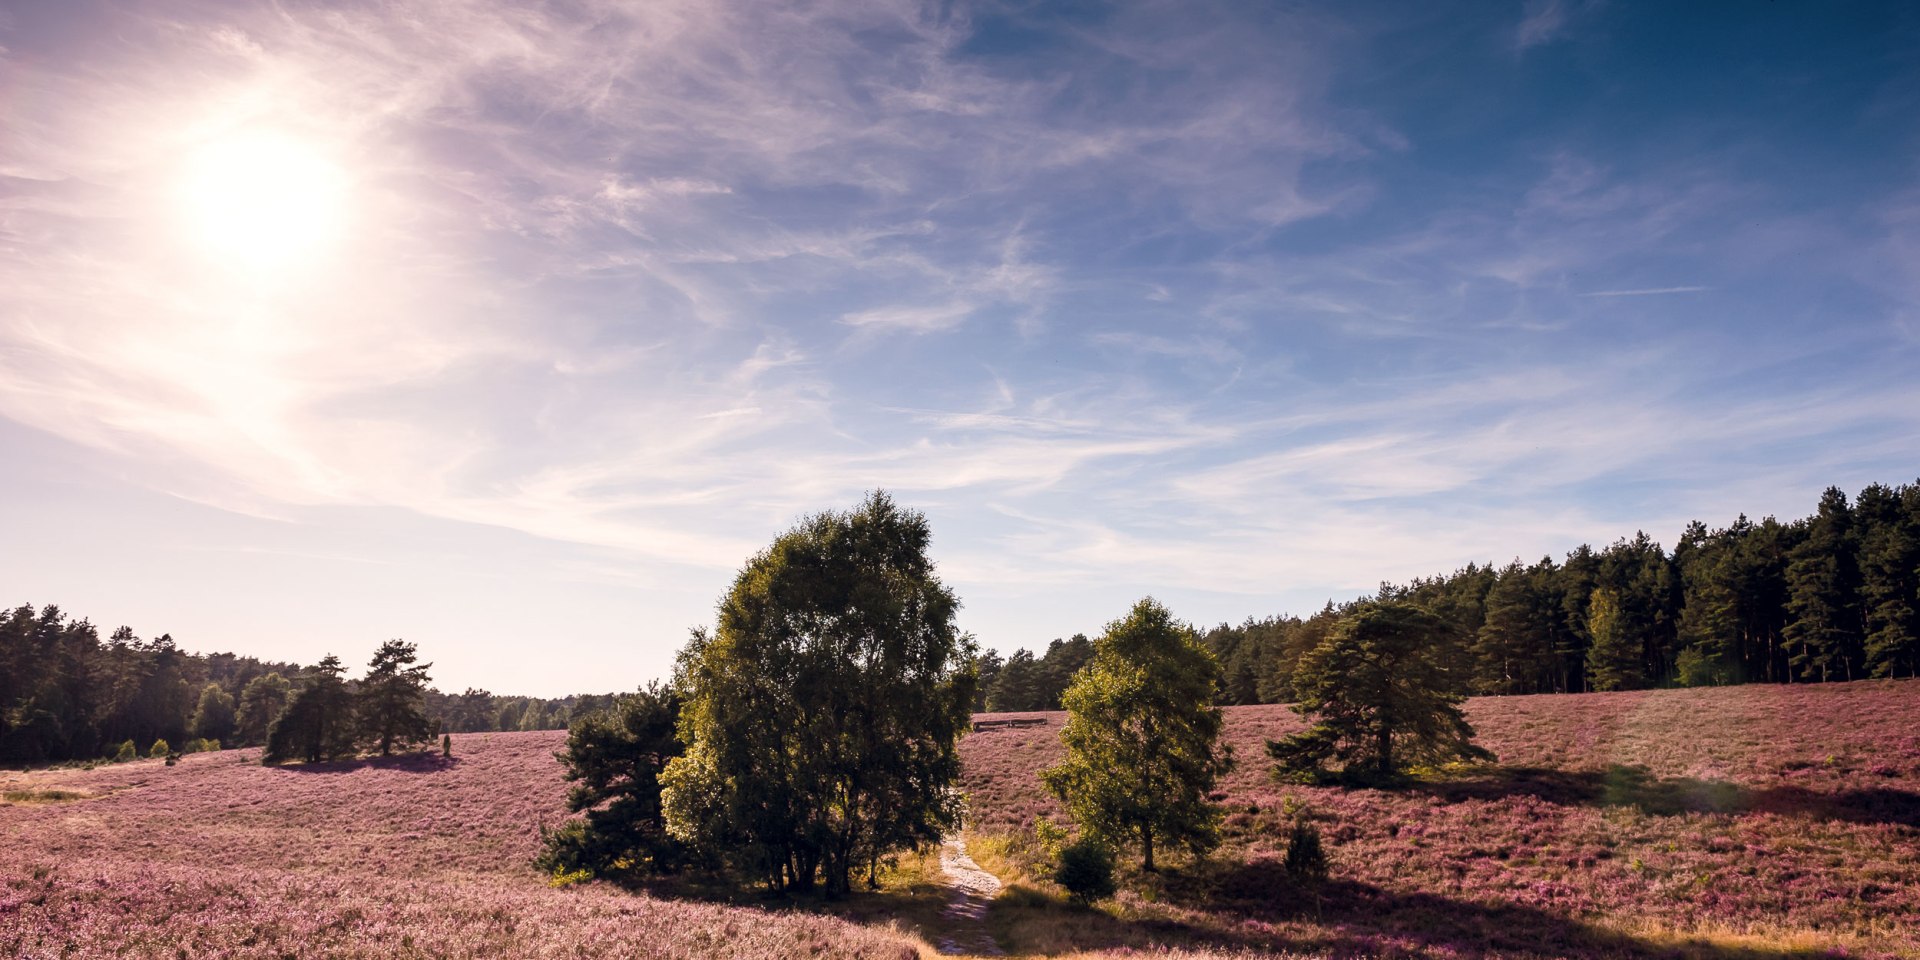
left=975, top=484, right=1920, bottom=710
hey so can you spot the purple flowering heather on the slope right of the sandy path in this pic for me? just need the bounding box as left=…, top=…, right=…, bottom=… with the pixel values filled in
left=962, top=682, right=1920, bottom=958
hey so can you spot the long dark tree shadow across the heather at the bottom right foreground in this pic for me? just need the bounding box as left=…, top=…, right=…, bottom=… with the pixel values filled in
left=1167, top=860, right=1832, bottom=960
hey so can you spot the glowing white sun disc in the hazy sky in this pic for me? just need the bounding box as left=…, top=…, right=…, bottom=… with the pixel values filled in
left=180, top=132, right=349, bottom=273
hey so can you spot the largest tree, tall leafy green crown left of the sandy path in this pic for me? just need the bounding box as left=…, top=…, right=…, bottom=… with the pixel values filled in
left=660, top=493, right=975, bottom=895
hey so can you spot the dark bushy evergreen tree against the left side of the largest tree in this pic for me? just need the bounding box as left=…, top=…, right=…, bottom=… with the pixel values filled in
left=540, top=684, right=687, bottom=876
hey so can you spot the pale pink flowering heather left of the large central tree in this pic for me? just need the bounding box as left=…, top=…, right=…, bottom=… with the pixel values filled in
left=0, top=732, right=918, bottom=960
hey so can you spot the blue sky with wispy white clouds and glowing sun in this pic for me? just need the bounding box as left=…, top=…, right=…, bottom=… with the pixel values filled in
left=0, top=0, right=1920, bottom=697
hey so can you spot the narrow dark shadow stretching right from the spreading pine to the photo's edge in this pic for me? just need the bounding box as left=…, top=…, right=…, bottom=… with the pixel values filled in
left=1411, top=764, right=1920, bottom=829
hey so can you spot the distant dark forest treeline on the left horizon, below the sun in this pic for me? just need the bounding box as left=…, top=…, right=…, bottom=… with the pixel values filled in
left=0, top=605, right=612, bottom=764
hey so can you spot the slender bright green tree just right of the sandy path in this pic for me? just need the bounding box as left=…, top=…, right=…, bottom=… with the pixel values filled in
left=1041, top=599, right=1233, bottom=870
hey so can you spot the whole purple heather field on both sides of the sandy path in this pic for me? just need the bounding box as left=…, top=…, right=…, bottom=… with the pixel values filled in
left=0, top=682, right=1920, bottom=960
